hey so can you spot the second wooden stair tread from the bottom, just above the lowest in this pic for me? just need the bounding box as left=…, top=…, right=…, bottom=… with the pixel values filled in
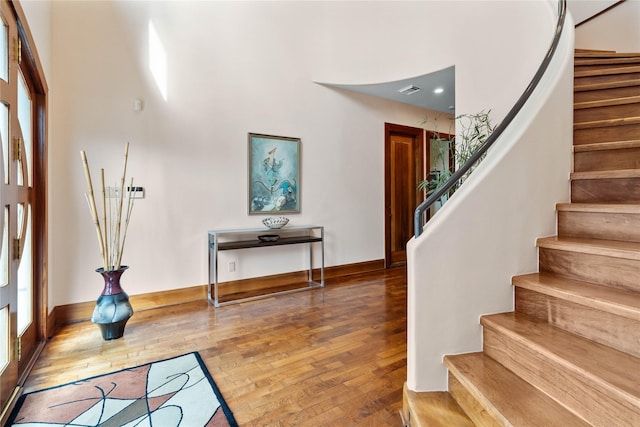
left=445, top=353, right=589, bottom=427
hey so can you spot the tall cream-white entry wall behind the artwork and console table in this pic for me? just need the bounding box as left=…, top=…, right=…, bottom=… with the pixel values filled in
left=17, top=1, right=550, bottom=308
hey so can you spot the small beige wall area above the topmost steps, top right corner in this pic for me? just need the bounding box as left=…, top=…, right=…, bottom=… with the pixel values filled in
left=576, top=0, right=640, bottom=52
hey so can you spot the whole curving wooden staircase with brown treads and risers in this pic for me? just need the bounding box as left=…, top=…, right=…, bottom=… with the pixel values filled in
left=403, top=51, right=640, bottom=427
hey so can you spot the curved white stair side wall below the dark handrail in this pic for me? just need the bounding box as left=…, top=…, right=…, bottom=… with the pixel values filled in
left=407, top=4, right=573, bottom=391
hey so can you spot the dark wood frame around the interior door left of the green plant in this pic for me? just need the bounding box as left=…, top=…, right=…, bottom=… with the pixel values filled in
left=384, top=123, right=425, bottom=268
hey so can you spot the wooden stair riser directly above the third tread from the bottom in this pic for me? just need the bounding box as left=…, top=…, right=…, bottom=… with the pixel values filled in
left=516, top=288, right=640, bottom=357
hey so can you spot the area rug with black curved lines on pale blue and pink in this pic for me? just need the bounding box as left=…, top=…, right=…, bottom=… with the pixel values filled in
left=7, top=352, right=238, bottom=427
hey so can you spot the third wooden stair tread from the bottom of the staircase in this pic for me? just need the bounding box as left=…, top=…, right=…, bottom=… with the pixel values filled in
left=480, top=312, right=640, bottom=405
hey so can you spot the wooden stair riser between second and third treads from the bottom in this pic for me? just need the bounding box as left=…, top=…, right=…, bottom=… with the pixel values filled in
left=483, top=325, right=640, bottom=427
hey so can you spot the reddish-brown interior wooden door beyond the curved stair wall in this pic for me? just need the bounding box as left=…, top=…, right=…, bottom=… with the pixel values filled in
left=385, top=123, right=424, bottom=267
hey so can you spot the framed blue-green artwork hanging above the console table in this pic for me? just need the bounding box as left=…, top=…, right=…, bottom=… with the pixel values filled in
left=249, top=133, right=300, bottom=215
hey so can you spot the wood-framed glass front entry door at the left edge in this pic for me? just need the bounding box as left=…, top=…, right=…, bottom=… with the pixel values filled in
left=0, top=0, right=47, bottom=423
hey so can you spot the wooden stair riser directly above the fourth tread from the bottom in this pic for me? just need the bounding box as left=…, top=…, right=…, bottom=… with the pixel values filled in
left=538, top=248, right=640, bottom=291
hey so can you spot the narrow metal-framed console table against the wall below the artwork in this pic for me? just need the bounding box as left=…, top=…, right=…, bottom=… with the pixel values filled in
left=207, top=225, right=324, bottom=307
